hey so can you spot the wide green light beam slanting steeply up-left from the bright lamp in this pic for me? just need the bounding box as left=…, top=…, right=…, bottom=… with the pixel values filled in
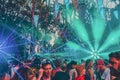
left=64, top=9, right=93, bottom=50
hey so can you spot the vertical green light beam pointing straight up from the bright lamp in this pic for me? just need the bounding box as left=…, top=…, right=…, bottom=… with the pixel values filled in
left=92, top=12, right=105, bottom=50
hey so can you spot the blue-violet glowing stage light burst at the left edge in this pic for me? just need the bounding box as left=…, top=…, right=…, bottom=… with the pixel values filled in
left=0, top=24, right=20, bottom=59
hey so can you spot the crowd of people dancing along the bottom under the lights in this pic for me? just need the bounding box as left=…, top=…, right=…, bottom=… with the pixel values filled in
left=0, top=51, right=120, bottom=80
